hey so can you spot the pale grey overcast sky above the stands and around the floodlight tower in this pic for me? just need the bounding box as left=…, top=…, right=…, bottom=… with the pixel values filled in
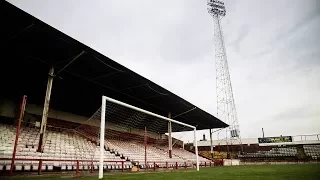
left=9, top=0, right=320, bottom=141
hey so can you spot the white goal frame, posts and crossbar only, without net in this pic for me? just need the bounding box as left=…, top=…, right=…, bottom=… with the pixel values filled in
left=99, top=96, right=199, bottom=179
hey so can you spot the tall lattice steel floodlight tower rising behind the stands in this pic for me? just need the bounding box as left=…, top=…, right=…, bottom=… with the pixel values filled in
left=207, top=0, right=241, bottom=145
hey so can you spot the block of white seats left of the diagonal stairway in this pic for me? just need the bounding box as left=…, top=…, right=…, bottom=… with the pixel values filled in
left=0, top=125, right=132, bottom=171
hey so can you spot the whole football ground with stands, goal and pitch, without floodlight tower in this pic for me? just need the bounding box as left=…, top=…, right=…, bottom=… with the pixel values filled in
left=0, top=1, right=320, bottom=180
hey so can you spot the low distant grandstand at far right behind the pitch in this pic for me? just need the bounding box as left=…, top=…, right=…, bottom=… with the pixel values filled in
left=198, top=134, right=320, bottom=163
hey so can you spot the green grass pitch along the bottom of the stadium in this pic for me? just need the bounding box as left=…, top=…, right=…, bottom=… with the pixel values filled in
left=6, top=164, right=320, bottom=180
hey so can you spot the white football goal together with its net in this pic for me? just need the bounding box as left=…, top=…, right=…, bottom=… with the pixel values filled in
left=74, top=96, right=199, bottom=178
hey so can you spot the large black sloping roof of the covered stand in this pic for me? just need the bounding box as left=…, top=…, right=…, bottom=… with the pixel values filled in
left=1, top=1, right=228, bottom=130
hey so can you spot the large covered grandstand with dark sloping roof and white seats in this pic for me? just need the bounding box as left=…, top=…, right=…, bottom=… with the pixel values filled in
left=0, top=1, right=228, bottom=175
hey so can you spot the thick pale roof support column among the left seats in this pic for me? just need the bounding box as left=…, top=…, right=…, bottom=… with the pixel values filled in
left=37, top=67, right=54, bottom=152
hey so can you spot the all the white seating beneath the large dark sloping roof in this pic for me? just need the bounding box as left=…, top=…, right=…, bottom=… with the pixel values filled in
left=0, top=124, right=210, bottom=171
